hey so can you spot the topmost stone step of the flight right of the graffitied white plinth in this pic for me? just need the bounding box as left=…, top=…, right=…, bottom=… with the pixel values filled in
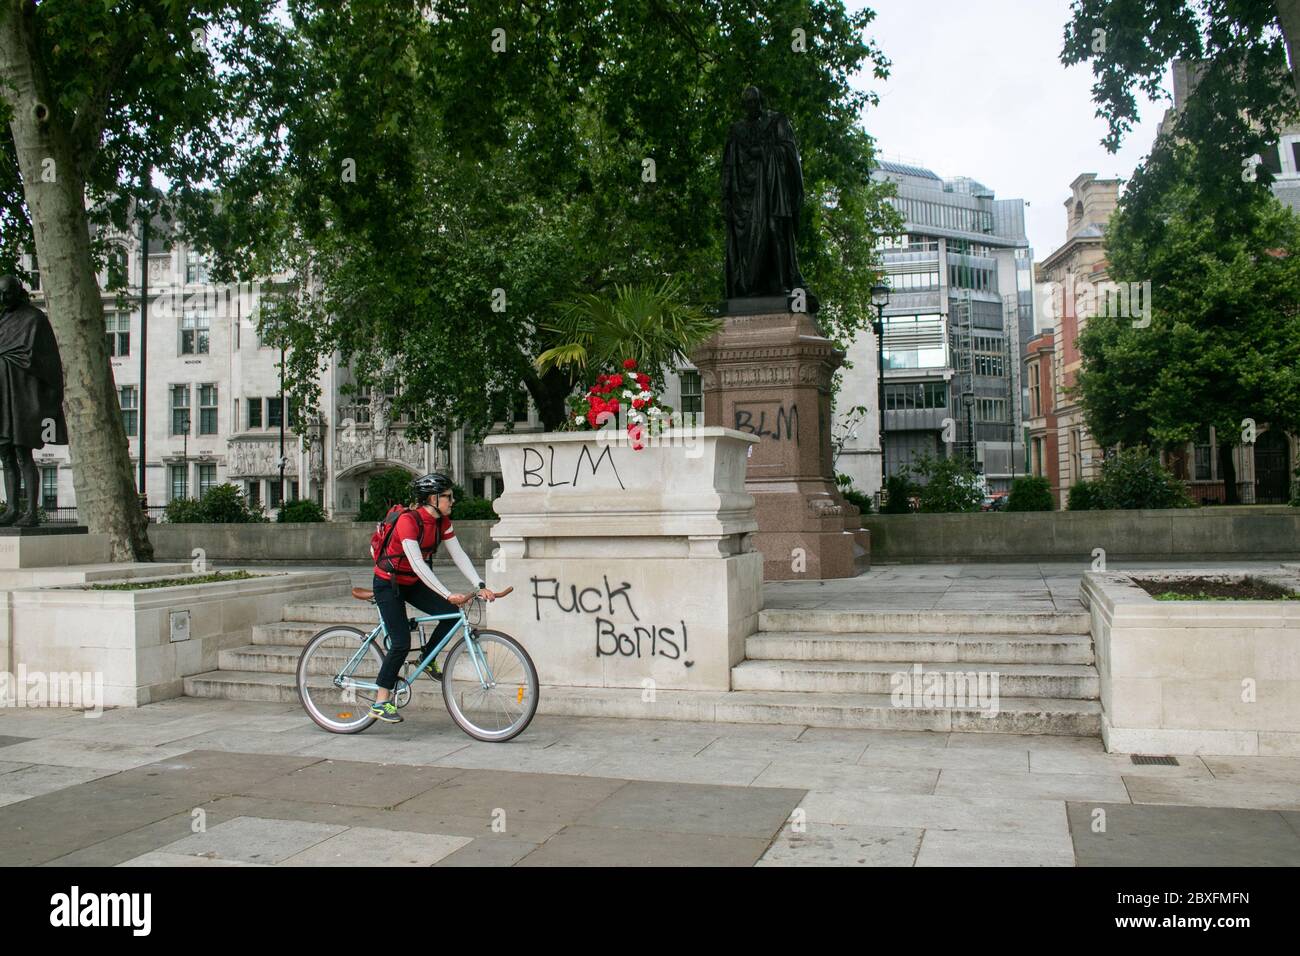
left=758, top=607, right=1091, bottom=635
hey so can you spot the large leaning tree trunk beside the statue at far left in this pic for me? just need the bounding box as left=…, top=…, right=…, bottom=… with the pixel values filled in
left=0, top=0, right=153, bottom=561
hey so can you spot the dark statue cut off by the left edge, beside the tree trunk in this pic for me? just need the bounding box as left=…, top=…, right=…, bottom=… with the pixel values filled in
left=0, top=276, right=68, bottom=528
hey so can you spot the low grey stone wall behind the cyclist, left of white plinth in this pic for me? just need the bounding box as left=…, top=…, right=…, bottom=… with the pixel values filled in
left=150, top=520, right=495, bottom=570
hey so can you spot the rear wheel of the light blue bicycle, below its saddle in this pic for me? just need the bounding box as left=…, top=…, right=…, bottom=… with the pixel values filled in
left=296, top=626, right=384, bottom=734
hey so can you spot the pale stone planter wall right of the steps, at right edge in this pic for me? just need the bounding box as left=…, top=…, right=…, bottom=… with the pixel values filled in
left=1080, top=567, right=1300, bottom=756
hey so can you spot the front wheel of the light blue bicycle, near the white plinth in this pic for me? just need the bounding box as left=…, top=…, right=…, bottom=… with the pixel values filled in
left=442, top=631, right=538, bottom=743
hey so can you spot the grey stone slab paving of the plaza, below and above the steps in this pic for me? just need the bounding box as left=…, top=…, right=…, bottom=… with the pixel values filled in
left=0, top=563, right=1300, bottom=866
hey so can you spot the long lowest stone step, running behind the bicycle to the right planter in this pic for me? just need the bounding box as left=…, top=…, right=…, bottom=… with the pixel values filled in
left=185, top=671, right=1101, bottom=737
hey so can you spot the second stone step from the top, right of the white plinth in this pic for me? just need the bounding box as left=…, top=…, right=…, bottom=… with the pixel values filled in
left=745, top=631, right=1093, bottom=663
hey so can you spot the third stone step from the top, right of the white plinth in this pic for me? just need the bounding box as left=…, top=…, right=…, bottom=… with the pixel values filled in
left=732, top=661, right=1100, bottom=700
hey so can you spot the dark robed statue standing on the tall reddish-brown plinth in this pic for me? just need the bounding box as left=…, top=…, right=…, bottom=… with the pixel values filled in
left=723, top=86, right=803, bottom=299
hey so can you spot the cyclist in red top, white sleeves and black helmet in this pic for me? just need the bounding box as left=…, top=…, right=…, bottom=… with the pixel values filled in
left=371, top=472, right=494, bottom=723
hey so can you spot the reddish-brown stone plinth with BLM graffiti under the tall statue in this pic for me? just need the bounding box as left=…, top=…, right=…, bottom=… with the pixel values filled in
left=693, top=299, right=870, bottom=580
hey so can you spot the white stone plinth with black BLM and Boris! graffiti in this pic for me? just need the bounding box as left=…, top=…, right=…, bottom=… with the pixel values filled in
left=486, top=428, right=763, bottom=695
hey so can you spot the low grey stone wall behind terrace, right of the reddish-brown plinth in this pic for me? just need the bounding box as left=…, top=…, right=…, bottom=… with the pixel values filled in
left=862, top=505, right=1300, bottom=563
